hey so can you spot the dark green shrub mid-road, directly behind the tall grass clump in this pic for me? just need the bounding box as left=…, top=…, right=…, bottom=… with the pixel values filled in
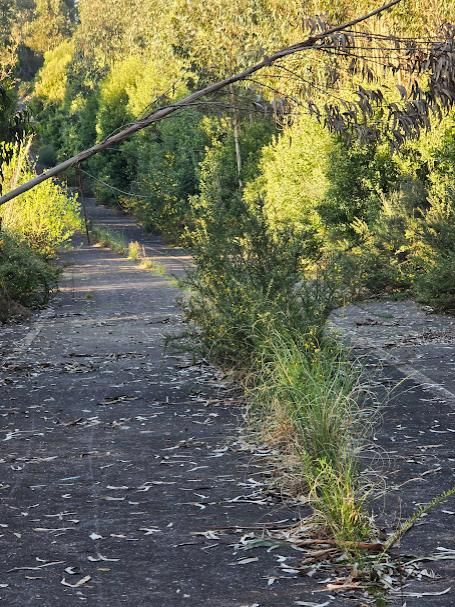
left=185, top=200, right=333, bottom=368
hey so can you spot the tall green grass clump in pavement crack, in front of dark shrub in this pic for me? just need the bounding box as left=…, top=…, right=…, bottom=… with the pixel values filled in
left=252, top=326, right=372, bottom=545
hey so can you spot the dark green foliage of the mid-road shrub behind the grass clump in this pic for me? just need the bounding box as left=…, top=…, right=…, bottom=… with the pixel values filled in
left=185, top=214, right=310, bottom=366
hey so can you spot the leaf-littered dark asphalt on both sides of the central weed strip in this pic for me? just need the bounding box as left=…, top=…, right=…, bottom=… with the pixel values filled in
left=0, top=201, right=455, bottom=607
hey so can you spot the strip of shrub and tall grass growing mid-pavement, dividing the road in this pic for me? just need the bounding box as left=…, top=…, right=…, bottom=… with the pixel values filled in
left=184, top=201, right=374, bottom=553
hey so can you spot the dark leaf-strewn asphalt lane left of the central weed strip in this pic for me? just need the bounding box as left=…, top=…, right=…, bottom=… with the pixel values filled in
left=0, top=204, right=343, bottom=607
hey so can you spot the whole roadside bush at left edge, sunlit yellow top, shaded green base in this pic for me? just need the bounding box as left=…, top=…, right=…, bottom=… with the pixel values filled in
left=0, top=141, right=77, bottom=321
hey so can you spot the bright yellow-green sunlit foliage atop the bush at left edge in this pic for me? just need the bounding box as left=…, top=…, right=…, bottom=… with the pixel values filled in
left=0, top=146, right=81, bottom=257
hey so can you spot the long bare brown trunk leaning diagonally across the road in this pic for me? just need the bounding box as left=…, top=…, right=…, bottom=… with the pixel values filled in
left=0, top=0, right=401, bottom=205
